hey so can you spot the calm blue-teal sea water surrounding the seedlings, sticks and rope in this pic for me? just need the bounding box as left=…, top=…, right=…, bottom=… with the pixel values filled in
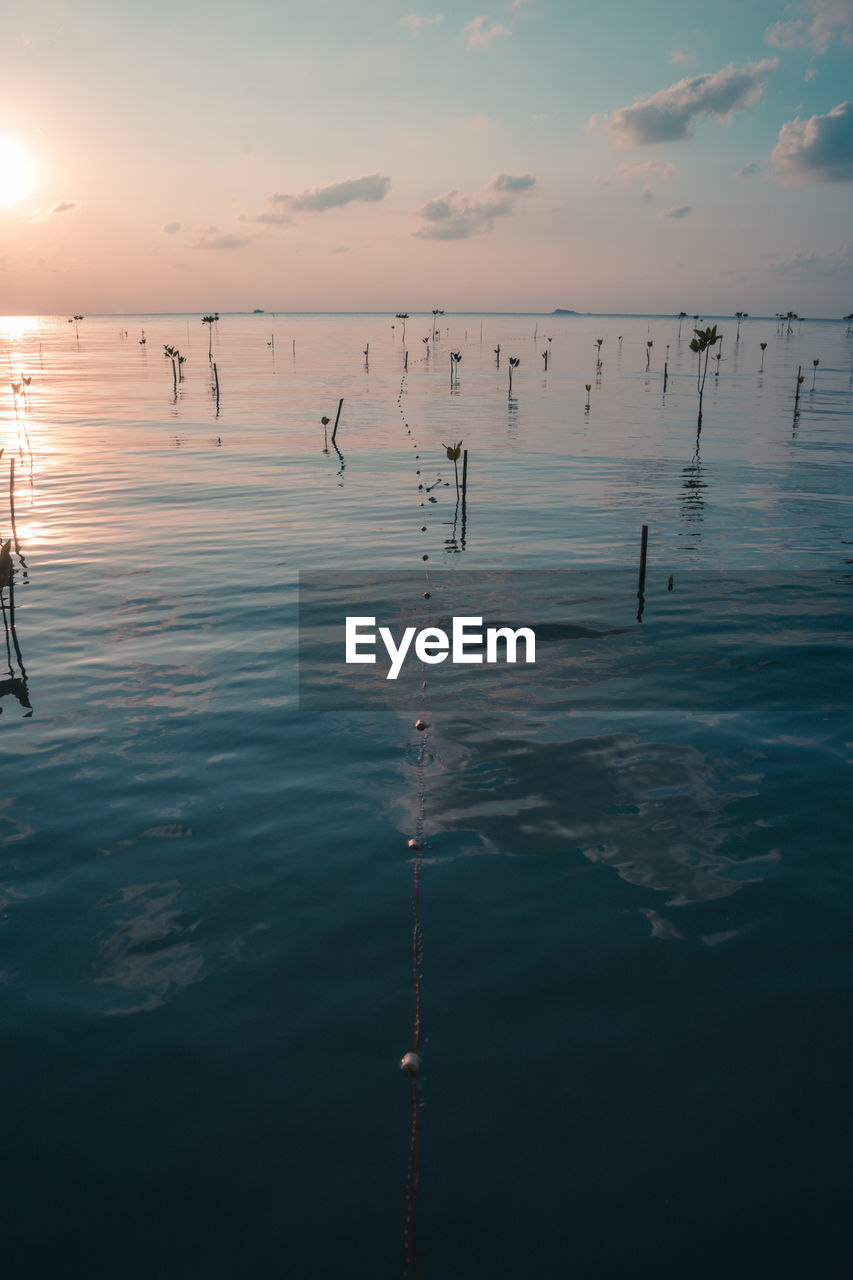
left=0, top=315, right=853, bottom=1280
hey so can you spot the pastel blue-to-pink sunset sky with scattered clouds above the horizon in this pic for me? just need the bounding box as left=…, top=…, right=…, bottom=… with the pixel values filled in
left=0, top=0, right=853, bottom=317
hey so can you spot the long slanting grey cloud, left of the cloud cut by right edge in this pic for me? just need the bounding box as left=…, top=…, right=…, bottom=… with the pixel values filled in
left=587, top=58, right=779, bottom=151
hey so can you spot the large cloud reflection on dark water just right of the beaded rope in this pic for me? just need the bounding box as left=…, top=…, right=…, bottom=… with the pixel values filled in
left=414, top=721, right=779, bottom=906
